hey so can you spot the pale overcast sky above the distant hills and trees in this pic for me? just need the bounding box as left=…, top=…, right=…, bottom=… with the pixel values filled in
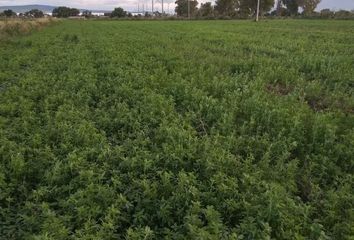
left=0, top=0, right=354, bottom=10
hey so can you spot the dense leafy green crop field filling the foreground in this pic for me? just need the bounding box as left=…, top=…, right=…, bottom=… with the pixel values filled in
left=0, top=20, right=354, bottom=240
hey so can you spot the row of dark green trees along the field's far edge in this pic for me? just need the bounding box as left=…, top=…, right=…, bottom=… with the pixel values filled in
left=0, top=0, right=354, bottom=18
